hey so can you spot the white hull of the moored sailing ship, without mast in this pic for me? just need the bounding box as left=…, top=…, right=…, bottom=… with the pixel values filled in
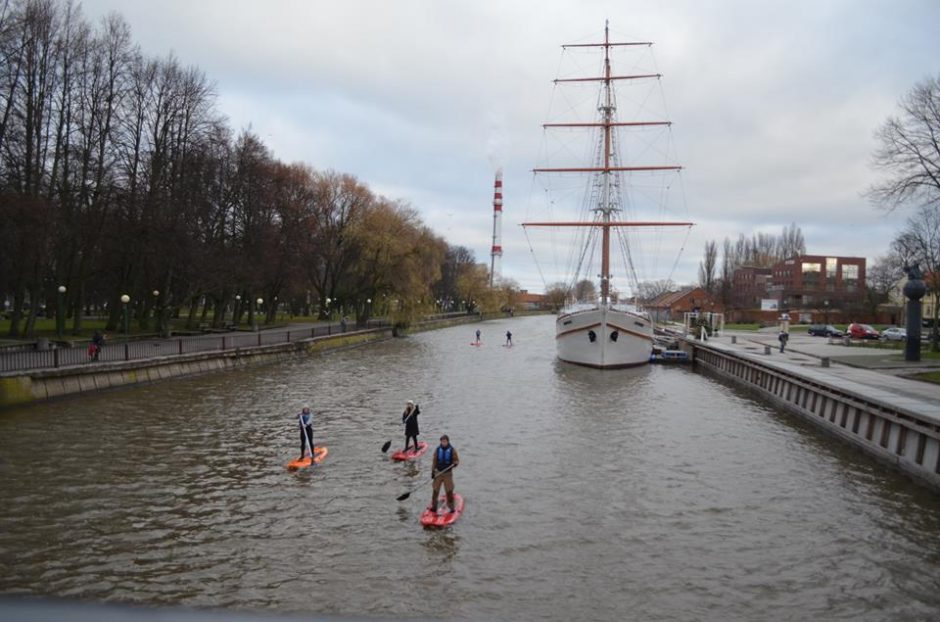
left=555, top=306, right=653, bottom=369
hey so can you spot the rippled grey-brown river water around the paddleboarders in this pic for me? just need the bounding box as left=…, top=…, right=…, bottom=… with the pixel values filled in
left=0, top=316, right=940, bottom=621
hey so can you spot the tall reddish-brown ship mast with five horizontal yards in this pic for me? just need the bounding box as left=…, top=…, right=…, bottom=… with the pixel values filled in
left=522, top=22, right=692, bottom=306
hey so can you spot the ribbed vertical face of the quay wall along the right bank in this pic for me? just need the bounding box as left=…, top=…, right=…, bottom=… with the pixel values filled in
left=685, top=342, right=940, bottom=489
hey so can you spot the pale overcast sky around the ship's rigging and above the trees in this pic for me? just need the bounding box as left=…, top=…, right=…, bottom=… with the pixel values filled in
left=82, top=0, right=940, bottom=291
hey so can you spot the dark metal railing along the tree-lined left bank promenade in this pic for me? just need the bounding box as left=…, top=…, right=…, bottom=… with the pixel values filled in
left=0, top=320, right=389, bottom=372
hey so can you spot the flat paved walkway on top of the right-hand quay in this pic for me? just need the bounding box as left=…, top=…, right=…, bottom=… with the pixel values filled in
left=707, top=330, right=940, bottom=422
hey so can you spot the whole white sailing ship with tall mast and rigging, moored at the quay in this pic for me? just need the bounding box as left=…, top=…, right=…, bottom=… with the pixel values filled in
left=523, top=24, right=693, bottom=369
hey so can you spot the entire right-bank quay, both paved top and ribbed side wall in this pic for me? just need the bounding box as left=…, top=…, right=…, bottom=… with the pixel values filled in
left=682, top=330, right=940, bottom=490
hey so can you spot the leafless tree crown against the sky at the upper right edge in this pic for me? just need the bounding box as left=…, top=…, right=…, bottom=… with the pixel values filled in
left=868, top=75, right=940, bottom=211
